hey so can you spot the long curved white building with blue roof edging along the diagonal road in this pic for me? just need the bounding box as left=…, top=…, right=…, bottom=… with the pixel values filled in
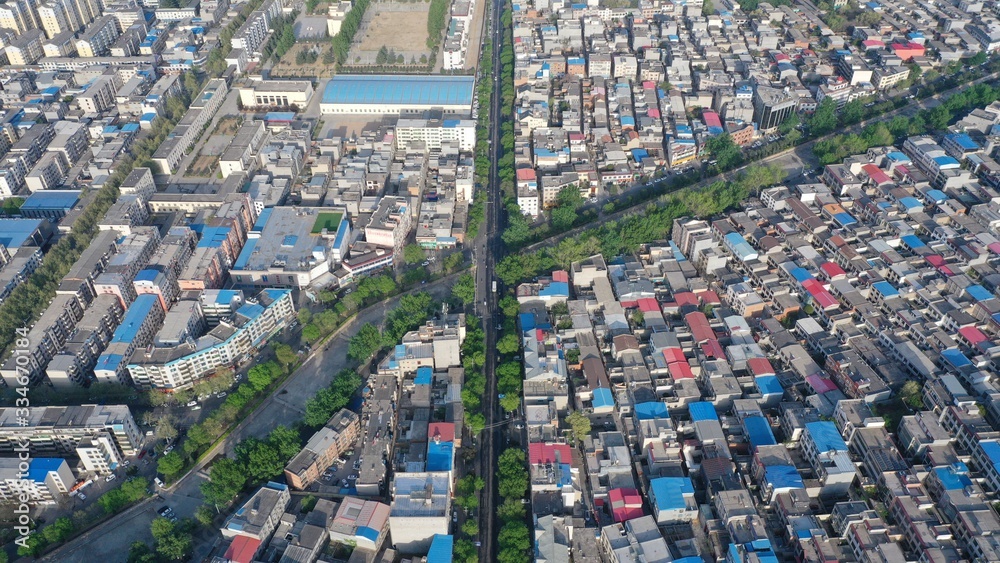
left=128, top=289, right=296, bottom=390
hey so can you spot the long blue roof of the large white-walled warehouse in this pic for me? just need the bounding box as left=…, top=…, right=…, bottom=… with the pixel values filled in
left=323, top=75, right=476, bottom=106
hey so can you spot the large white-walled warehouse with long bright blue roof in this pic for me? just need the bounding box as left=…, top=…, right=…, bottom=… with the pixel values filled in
left=319, top=74, right=476, bottom=115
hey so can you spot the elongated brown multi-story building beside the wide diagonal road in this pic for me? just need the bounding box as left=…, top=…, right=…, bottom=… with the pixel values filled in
left=285, top=409, right=362, bottom=490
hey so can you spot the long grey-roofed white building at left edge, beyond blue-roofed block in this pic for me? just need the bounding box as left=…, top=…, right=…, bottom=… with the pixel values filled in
left=0, top=405, right=142, bottom=456
